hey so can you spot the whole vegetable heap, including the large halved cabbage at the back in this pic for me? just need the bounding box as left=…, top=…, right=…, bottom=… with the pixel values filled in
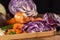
left=0, top=0, right=60, bottom=35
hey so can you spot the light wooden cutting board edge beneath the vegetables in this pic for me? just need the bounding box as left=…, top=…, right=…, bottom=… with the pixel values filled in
left=0, top=30, right=56, bottom=40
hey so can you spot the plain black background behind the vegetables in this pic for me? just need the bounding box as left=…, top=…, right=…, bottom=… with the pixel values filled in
left=0, top=0, right=60, bottom=14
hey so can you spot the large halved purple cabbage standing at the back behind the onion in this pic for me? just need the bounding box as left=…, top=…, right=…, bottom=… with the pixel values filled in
left=9, top=0, right=38, bottom=16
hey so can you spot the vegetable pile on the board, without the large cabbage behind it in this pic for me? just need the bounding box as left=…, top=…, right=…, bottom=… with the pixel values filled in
left=1, top=12, right=60, bottom=35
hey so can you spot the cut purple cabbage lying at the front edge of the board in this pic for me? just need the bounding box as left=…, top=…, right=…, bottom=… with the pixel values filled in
left=22, top=20, right=54, bottom=33
